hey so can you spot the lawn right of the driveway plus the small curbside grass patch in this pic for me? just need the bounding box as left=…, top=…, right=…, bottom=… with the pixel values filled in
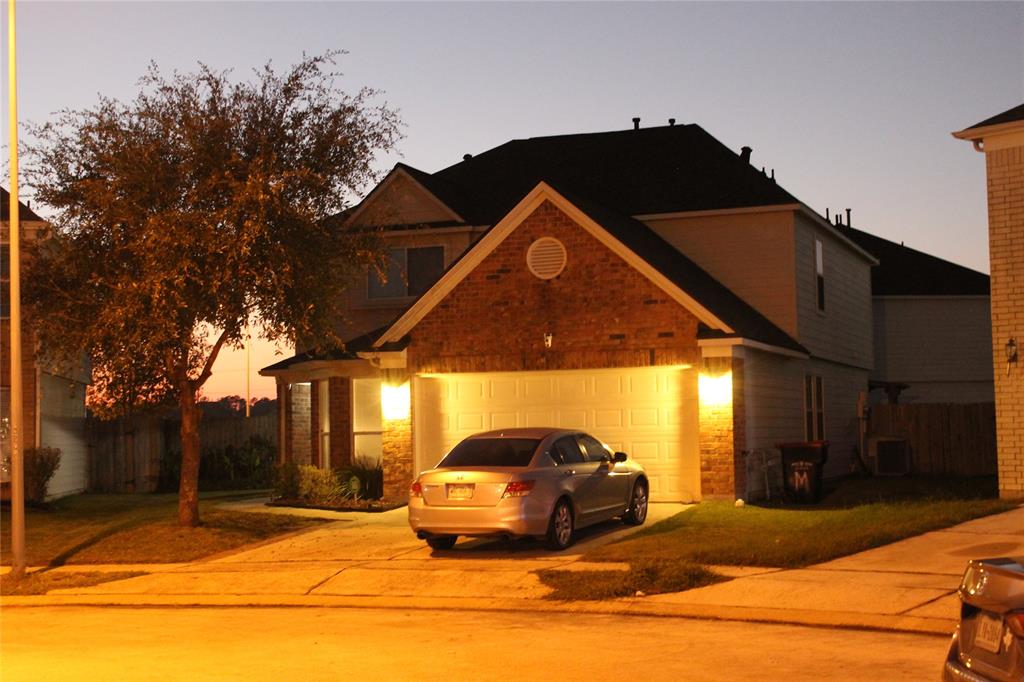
left=540, top=477, right=1020, bottom=599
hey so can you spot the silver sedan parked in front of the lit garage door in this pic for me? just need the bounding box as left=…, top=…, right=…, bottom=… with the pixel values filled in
left=409, top=428, right=650, bottom=550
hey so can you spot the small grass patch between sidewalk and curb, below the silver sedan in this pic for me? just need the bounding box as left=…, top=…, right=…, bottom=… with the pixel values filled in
left=538, top=559, right=729, bottom=600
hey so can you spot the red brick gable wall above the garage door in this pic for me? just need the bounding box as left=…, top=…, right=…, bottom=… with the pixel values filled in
left=408, top=202, right=700, bottom=372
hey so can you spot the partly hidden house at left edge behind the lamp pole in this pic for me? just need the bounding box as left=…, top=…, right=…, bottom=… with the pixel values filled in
left=0, top=188, right=89, bottom=498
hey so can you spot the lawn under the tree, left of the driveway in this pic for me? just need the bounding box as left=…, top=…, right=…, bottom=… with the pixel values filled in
left=0, top=494, right=325, bottom=566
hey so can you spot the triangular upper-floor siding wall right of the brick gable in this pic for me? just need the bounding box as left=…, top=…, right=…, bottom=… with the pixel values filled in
left=647, top=206, right=797, bottom=336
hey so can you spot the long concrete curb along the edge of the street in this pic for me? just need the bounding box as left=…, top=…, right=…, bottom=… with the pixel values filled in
left=0, top=595, right=956, bottom=637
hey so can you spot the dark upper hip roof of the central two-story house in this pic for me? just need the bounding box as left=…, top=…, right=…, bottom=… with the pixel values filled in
left=417, top=124, right=798, bottom=224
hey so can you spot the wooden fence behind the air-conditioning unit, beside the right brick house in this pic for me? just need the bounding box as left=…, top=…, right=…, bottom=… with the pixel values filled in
left=867, top=402, right=996, bottom=476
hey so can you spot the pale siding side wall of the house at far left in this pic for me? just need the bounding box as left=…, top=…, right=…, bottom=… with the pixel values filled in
left=39, top=372, right=89, bottom=498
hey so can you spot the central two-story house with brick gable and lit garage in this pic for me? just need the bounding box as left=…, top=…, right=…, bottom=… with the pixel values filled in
left=261, top=122, right=876, bottom=501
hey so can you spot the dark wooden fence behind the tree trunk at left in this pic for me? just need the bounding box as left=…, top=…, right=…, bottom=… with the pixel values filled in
left=89, top=414, right=278, bottom=493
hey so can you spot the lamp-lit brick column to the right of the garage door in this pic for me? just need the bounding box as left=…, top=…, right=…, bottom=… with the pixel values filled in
left=698, top=357, right=746, bottom=500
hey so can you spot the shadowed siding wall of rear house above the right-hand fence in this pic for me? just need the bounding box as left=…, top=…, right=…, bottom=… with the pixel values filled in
left=871, top=296, right=994, bottom=402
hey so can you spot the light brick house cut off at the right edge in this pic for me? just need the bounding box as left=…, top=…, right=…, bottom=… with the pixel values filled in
left=953, top=103, right=1024, bottom=498
